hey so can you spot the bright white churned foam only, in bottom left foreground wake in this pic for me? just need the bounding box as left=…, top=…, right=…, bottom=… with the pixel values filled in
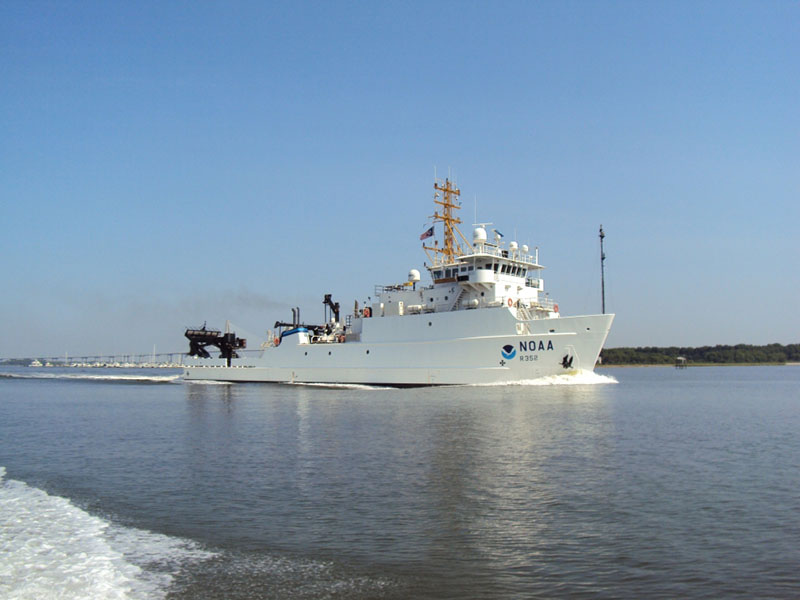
left=0, top=467, right=213, bottom=600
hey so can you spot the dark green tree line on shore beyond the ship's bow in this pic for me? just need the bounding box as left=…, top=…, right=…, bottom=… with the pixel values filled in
left=601, top=344, right=800, bottom=365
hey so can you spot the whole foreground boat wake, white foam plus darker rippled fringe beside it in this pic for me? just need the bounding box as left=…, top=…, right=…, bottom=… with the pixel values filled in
left=0, top=467, right=396, bottom=600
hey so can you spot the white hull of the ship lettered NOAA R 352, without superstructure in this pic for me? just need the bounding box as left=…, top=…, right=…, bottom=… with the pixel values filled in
left=184, top=307, right=614, bottom=386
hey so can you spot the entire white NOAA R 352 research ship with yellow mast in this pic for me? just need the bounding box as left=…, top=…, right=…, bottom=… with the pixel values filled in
left=184, top=179, right=614, bottom=387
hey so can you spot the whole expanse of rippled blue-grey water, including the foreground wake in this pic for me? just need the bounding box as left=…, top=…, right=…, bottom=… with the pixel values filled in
left=0, top=367, right=800, bottom=599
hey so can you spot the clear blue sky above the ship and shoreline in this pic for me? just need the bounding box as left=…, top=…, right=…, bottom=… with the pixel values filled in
left=0, top=1, right=800, bottom=357
